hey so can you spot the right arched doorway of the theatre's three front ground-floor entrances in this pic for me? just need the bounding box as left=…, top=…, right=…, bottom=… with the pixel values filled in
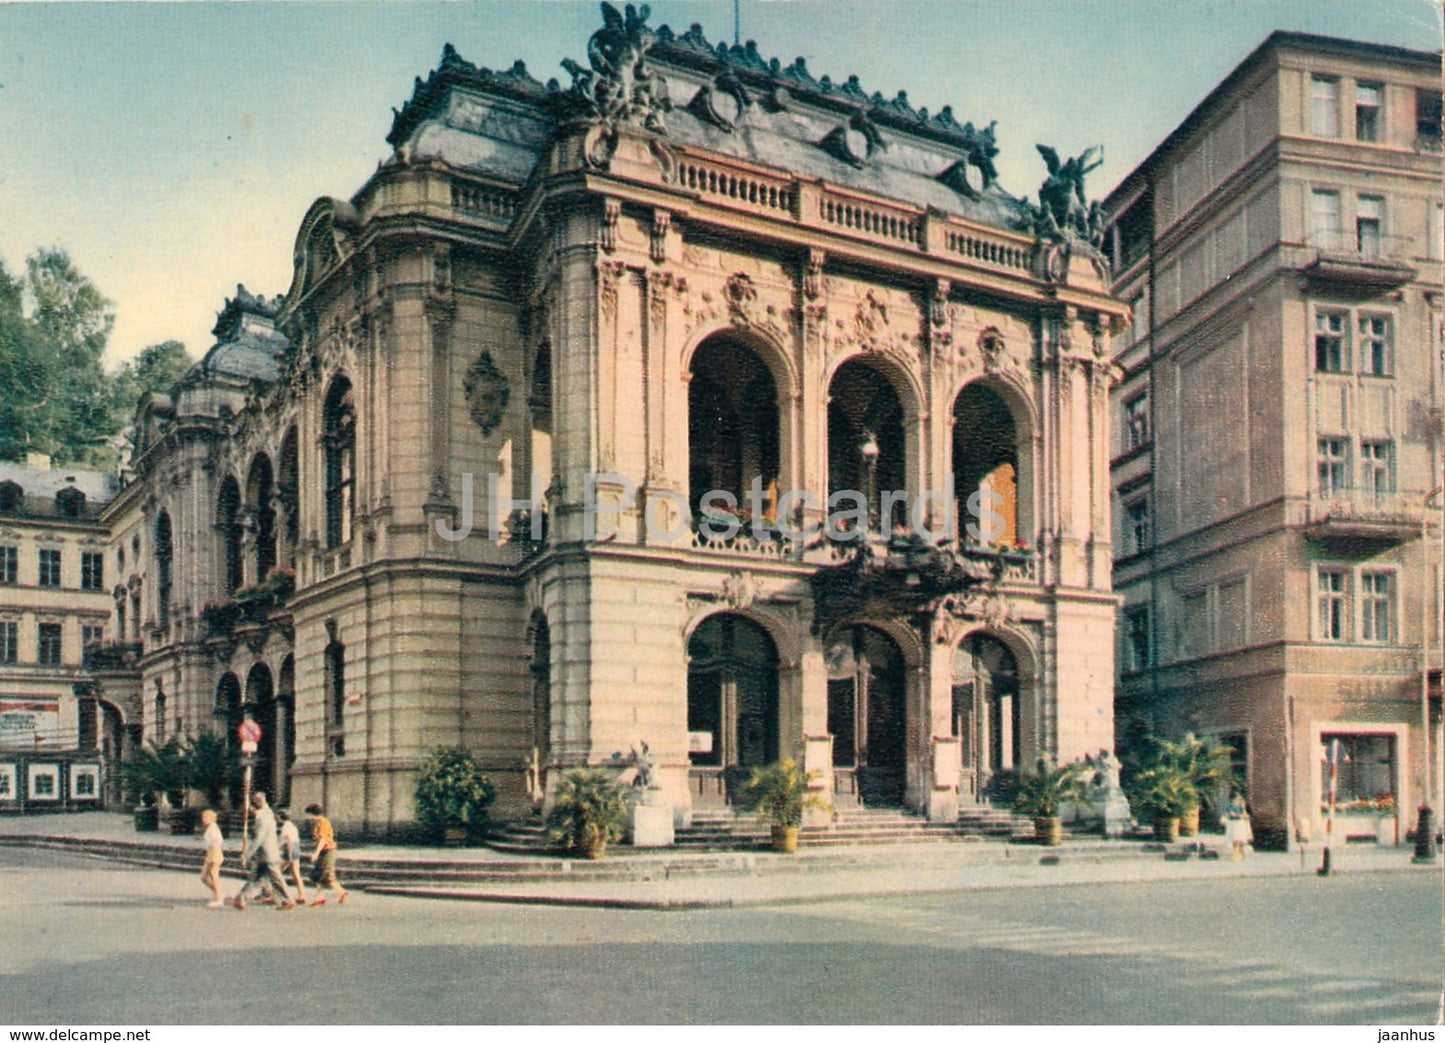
left=952, top=634, right=1023, bottom=797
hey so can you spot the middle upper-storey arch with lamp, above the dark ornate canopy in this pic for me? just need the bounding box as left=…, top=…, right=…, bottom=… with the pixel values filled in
left=828, top=360, right=907, bottom=530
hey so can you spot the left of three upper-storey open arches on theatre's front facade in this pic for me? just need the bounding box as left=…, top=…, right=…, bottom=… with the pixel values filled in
left=688, top=337, right=779, bottom=516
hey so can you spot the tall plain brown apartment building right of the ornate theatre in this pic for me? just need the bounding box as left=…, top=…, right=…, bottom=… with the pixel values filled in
left=1105, top=32, right=1445, bottom=842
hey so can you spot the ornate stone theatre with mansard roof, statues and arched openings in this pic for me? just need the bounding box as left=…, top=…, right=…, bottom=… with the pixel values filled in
left=90, top=4, right=1127, bottom=835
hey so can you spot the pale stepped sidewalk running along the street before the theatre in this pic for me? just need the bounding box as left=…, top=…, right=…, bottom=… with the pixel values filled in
left=0, top=812, right=1445, bottom=910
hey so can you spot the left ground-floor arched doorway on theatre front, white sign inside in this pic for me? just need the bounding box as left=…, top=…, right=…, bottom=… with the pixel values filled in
left=688, top=613, right=779, bottom=803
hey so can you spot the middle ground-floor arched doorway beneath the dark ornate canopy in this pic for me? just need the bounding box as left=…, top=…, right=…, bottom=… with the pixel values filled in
left=827, top=627, right=907, bottom=806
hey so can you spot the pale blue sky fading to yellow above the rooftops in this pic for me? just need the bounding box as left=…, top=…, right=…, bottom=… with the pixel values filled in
left=0, top=0, right=1441, bottom=368
